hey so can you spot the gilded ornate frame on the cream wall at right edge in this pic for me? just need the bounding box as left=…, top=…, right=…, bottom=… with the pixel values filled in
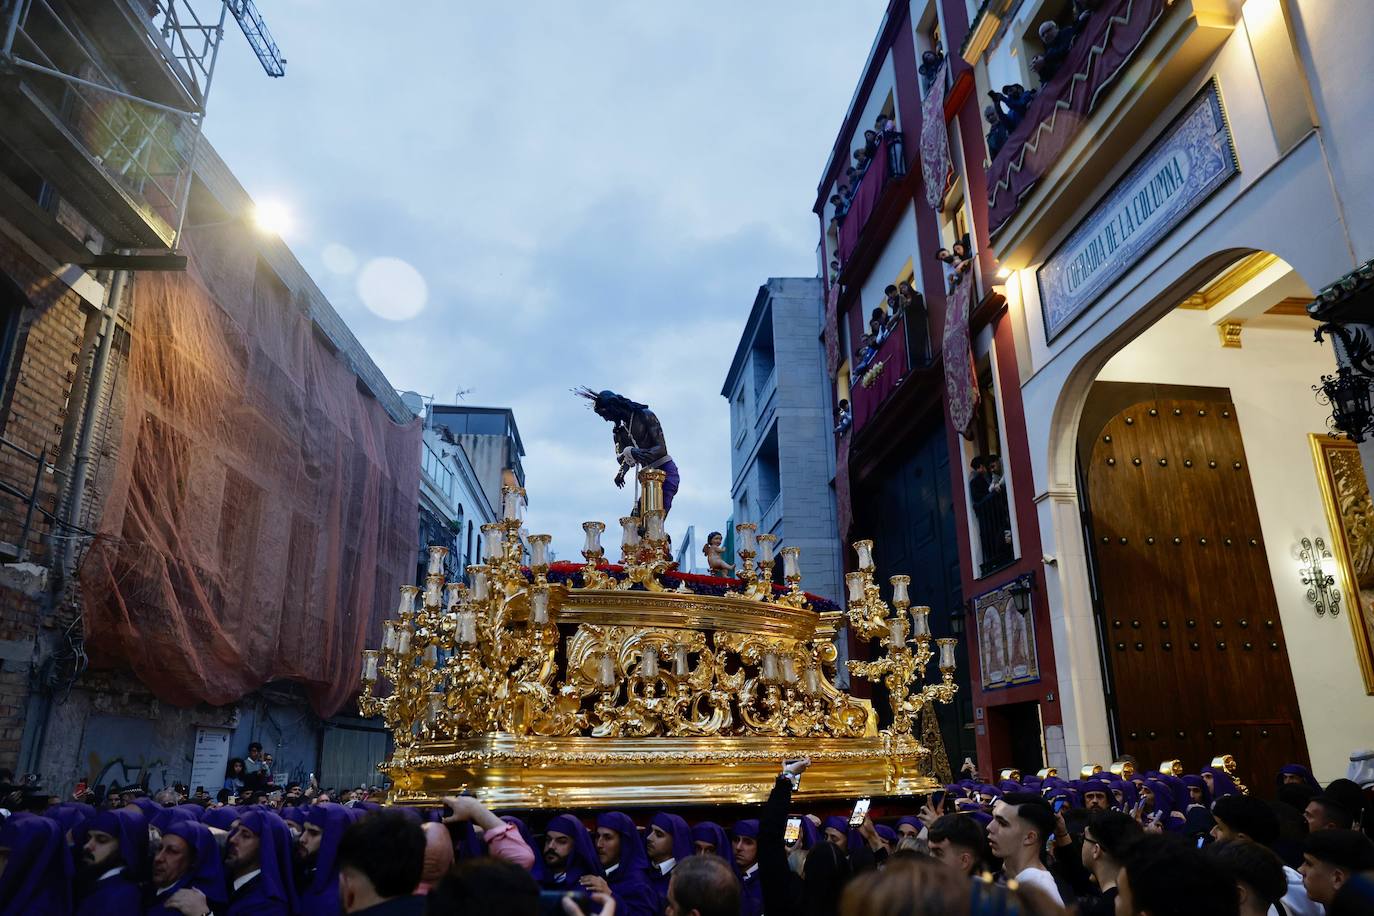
left=1308, top=433, right=1374, bottom=695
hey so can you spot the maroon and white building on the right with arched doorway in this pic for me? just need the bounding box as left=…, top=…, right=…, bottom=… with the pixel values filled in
left=816, top=0, right=1374, bottom=783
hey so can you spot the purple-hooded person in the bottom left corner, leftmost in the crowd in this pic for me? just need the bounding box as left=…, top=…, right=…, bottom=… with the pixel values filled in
left=0, top=814, right=74, bottom=916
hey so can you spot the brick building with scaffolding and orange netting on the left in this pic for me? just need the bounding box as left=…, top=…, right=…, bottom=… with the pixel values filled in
left=0, top=1, right=420, bottom=795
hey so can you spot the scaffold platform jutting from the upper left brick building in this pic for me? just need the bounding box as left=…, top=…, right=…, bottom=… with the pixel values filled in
left=0, top=0, right=223, bottom=251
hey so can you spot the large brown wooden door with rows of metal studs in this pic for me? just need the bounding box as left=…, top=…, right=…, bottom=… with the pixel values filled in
left=1085, top=397, right=1307, bottom=791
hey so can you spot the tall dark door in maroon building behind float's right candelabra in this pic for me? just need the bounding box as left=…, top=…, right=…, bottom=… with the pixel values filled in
left=855, top=427, right=977, bottom=773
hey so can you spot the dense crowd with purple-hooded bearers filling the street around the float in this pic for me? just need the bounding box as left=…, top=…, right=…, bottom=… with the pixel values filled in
left=0, top=759, right=1374, bottom=916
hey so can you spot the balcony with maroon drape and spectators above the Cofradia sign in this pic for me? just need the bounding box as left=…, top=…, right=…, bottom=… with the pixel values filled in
left=988, top=0, right=1235, bottom=266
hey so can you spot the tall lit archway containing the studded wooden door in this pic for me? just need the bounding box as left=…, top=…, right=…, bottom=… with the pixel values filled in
left=1050, top=250, right=1369, bottom=781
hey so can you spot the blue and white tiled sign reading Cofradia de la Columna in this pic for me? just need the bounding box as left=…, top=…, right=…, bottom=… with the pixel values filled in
left=1036, top=80, right=1239, bottom=341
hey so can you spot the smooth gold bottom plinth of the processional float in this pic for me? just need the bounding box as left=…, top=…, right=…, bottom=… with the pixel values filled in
left=382, top=735, right=937, bottom=809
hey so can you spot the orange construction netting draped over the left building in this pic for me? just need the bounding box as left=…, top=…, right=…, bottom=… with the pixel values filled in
left=80, top=231, right=420, bottom=715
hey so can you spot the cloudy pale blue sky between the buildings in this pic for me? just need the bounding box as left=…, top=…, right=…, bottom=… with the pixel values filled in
left=206, top=0, right=886, bottom=574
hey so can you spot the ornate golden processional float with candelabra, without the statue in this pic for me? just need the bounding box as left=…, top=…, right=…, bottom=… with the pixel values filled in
left=359, top=470, right=956, bottom=808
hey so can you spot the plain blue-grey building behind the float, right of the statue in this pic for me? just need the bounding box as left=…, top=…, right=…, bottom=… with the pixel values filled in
left=725, top=277, right=844, bottom=609
